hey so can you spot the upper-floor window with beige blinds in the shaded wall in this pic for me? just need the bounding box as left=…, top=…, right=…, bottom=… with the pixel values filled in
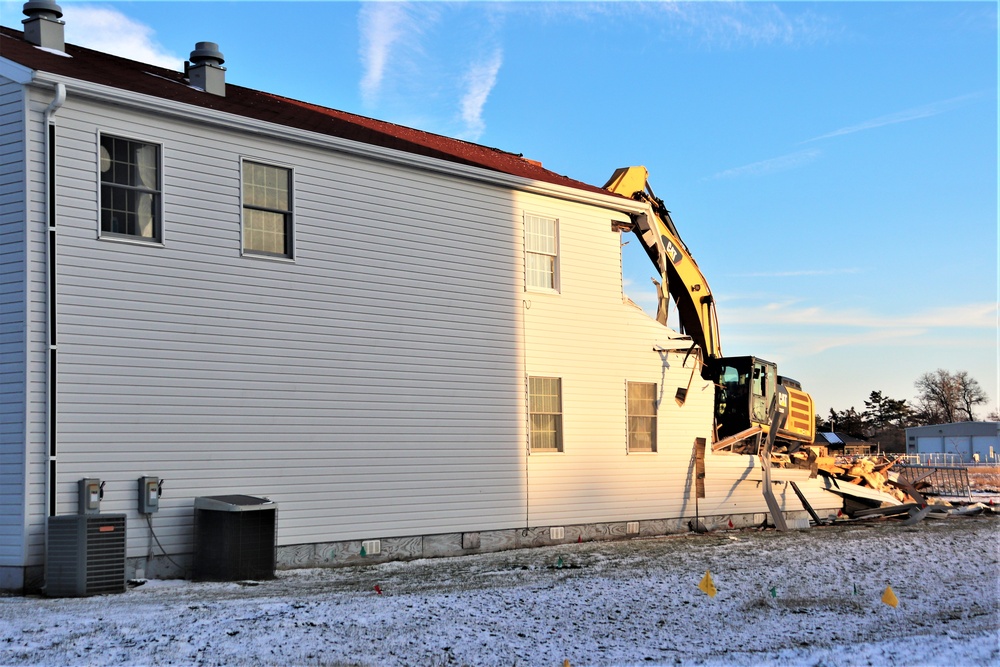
left=243, top=162, right=292, bottom=257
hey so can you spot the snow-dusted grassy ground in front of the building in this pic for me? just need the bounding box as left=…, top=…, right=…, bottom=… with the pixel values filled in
left=0, top=516, right=1000, bottom=667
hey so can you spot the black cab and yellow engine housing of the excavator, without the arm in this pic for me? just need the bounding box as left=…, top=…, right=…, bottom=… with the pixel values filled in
left=713, top=357, right=815, bottom=442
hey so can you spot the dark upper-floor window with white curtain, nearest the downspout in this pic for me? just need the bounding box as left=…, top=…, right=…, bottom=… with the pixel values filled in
left=101, top=134, right=160, bottom=241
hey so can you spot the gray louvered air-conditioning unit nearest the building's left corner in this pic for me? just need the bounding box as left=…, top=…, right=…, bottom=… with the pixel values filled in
left=44, top=514, right=125, bottom=597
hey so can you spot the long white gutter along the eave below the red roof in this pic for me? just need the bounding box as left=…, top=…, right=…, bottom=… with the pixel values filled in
left=25, top=71, right=646, bottom=219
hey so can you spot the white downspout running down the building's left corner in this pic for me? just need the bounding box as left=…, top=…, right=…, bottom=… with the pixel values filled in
left=42, top=83, right=66, bottom=552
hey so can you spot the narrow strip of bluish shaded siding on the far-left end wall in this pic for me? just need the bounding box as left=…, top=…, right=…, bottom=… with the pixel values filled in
left=0, top=78, right=27, bottom=566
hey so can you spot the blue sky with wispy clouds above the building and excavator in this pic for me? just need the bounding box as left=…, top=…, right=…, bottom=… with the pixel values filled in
left=0, top=0, right=1000, bottom=417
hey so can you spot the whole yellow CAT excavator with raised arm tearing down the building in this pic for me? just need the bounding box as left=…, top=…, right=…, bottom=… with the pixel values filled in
left=604, top=167, right=816, bottom=453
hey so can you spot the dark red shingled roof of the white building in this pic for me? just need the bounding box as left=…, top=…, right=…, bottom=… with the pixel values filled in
left=0, top=27, right=608, bottom=194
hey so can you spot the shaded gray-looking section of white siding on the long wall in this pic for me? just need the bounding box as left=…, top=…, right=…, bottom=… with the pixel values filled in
left=47, top=97, right=525, bottom=556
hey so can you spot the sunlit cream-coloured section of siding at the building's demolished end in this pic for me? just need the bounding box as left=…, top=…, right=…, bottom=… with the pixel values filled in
left=518, top=194, right=842, bottom=530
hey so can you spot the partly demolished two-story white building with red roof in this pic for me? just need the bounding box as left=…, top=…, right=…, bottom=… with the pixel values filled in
left=0, top=2, right=840, bottom=590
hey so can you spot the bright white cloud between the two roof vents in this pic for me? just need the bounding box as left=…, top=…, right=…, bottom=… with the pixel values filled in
left=62, top=3, right=182, bottom=70
